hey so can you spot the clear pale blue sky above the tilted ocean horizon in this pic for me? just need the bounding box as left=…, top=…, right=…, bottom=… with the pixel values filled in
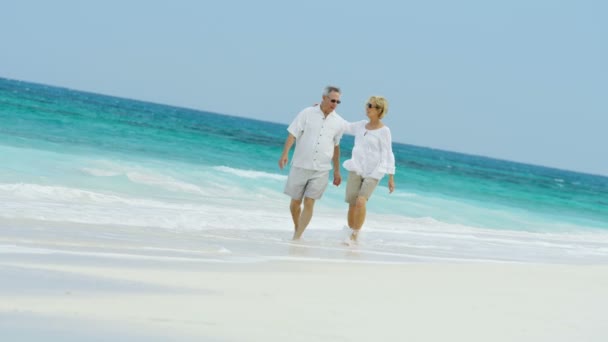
left=0, top=0, right=608, bottom=175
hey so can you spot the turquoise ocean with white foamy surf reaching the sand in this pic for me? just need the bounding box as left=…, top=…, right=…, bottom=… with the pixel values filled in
left=0, top=78, right=608, bottom=263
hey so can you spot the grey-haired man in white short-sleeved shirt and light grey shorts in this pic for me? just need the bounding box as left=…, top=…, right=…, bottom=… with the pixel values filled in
left=279, top=86, right=346, bottom=240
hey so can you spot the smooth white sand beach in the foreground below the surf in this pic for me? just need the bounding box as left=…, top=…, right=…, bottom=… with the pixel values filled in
left=0, top=222, right=608, bottom=342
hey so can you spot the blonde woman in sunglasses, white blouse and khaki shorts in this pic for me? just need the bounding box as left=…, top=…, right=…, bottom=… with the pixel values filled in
left=343, top=96, right=395, bottom=243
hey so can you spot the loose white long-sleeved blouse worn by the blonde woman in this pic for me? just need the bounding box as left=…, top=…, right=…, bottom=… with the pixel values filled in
left=342, top=120, right=395, bottom=180
